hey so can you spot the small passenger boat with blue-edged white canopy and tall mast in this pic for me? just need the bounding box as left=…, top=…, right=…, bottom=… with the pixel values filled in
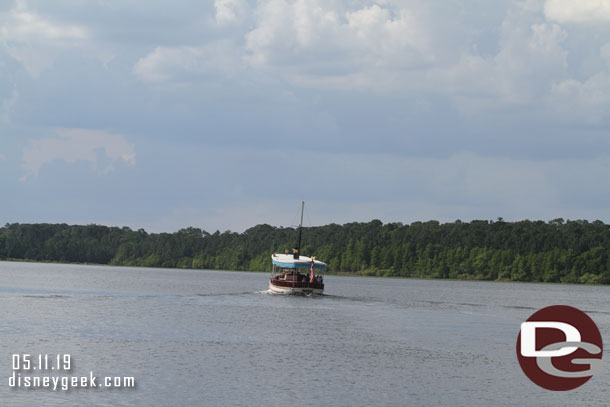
left=269, top=202, right=327, bottom=295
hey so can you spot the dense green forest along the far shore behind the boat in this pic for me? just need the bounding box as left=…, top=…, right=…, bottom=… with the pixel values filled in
left=0, top=218, right=610, bottom=284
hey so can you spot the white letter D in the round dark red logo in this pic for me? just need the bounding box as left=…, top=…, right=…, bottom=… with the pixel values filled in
left=521, top=321, right=581, bottom=357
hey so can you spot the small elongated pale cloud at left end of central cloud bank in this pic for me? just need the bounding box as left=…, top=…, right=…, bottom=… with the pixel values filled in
left=133, top=40, right=241, bottom=82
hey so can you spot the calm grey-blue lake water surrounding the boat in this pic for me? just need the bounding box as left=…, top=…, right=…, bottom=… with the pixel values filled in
left=0, top=262, right=610, bottom=407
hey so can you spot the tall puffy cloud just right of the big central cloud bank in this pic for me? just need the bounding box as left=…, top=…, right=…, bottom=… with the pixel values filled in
left=428, top=1, right=568, bottom=112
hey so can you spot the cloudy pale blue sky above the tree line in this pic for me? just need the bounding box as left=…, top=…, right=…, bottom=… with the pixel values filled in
left=0, top=0, right=610, bottom=232
